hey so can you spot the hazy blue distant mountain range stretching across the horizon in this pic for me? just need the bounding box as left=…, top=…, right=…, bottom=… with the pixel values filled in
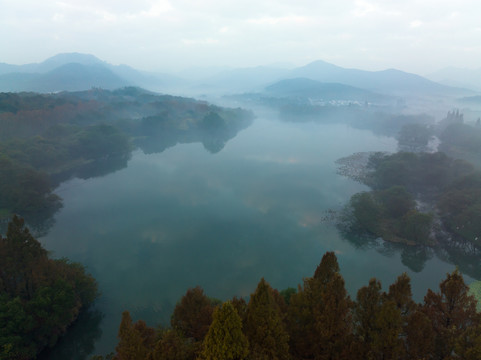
left=0, top=53, right=475, bottom=99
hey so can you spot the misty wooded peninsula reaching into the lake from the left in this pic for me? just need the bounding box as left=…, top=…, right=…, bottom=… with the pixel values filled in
left=0, top=88, right=253, bottom=231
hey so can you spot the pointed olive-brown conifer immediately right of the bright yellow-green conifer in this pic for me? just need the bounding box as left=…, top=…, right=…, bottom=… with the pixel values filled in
left=245, top=278, right=289, bottom=360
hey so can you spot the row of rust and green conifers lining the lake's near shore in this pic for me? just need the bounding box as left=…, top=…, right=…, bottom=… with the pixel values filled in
left=92, top=252, right=481, bottom=360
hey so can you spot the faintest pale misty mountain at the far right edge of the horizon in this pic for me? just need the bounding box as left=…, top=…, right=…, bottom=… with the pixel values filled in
left=426, top=67, right=481, bottom=91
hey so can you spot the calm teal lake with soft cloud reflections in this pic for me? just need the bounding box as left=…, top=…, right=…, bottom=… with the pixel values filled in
left=40, top=113, right=466, bottom=359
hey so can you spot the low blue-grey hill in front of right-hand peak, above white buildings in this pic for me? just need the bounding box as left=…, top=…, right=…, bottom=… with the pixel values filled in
left=265, top=78, right=386, bottom=102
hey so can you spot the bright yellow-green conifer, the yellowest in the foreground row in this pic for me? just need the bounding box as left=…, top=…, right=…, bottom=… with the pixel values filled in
left=202, top=302, right=249, bottom=360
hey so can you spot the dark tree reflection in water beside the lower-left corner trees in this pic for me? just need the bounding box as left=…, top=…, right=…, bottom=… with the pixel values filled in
left=38, top=310, right=103, bottom=360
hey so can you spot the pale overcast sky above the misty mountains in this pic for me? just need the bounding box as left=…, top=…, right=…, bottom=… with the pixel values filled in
left=0, top=0, right=481, bottom=75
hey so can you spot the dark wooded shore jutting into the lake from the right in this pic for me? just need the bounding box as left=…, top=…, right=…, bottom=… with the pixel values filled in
left=344, top=152, right=481, bottom=253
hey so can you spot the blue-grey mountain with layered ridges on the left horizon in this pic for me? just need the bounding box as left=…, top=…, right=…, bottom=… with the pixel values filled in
left=0, top=53, right=182, bottom=92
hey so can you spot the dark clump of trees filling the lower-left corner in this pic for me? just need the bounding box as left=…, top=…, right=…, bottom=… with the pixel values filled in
left=0, top=216, right=98, bottom=360
